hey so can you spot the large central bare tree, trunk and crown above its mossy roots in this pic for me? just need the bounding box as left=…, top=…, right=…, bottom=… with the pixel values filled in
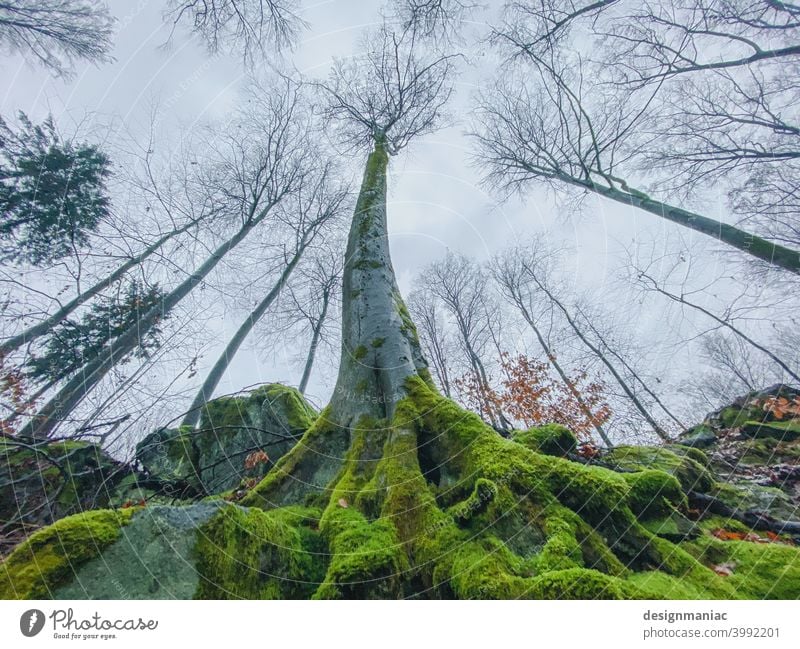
left=312, top=25, right=453, bottom=427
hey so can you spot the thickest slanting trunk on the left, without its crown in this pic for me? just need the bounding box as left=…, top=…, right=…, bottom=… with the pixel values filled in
left=15, top=208, right=269, bottom=438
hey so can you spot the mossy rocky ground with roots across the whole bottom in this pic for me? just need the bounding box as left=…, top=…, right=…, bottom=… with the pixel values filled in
left=0, top=385, right=800, bottom=599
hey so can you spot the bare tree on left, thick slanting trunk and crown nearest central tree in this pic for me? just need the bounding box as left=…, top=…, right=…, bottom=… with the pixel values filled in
left=22, top=79, right=314, bottom=437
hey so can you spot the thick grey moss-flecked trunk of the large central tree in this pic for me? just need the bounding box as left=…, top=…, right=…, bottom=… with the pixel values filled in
left=330, top=143, right=432, bottom=428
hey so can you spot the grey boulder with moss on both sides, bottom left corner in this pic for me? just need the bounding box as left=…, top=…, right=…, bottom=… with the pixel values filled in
left=0, top=500, right=325, bottom=599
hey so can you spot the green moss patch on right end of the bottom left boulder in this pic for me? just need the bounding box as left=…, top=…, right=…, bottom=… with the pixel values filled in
left=195, top=505, right=326, bottom=599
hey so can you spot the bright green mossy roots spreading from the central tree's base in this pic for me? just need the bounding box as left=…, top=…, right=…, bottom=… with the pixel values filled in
left=228, top=377, right=800, bottom=599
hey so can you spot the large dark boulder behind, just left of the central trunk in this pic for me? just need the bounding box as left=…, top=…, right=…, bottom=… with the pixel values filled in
left=136, top=383, right=317, bottom=495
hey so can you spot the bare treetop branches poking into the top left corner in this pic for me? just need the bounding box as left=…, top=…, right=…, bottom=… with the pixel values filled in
left=0, top=0, right=114, bottom=76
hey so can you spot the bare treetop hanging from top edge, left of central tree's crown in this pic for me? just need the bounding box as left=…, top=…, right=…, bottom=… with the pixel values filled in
left=165, top=0, right=307, bottom=63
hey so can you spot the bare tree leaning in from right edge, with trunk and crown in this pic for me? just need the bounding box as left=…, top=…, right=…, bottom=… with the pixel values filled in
left=473, top=61, right=800, bottom=273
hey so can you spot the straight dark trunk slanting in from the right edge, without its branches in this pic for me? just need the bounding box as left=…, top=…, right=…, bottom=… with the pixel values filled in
left=557, top=175, right=800, bottom=273
